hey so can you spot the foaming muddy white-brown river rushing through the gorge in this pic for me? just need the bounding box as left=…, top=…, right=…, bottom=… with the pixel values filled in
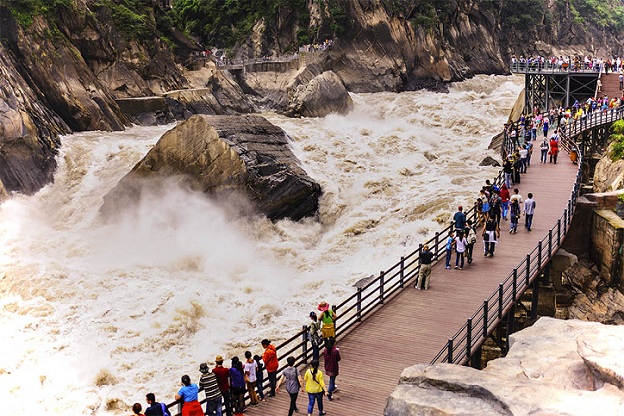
left=0, top=76, right=522, bottom=415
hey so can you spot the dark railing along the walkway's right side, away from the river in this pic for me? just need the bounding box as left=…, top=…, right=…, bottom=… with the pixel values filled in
left=431, top=107, right=624, bottom=364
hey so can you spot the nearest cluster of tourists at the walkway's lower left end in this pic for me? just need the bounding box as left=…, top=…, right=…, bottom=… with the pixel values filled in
left=132, top=302, right=341, bottom=416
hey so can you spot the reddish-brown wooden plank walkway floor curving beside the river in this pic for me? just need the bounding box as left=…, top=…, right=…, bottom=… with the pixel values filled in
left=245, top=154, right=577, bottom=416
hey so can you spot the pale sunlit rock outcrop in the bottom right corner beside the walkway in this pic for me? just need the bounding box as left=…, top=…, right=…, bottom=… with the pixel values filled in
left=384, top=318, right=624, bottom=416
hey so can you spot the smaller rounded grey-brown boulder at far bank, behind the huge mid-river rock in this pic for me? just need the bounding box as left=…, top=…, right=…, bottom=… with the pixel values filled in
left=286, top=71, right=353, bottom=117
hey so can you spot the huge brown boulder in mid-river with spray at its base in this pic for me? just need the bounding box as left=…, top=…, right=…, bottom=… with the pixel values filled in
left=102, top=115, right=321, bottom=220
